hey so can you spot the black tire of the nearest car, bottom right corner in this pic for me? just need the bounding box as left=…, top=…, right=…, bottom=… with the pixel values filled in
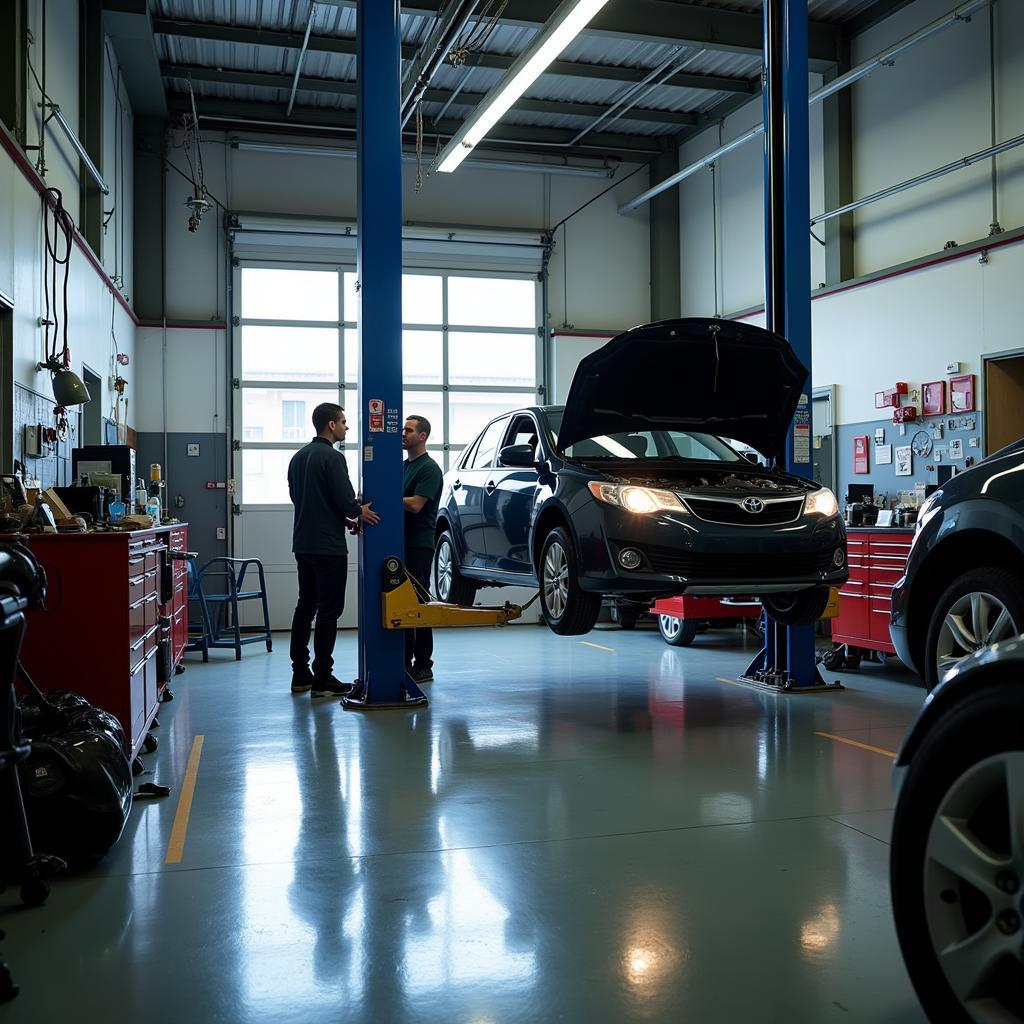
left=890, top=679, right=1024, bottom=1024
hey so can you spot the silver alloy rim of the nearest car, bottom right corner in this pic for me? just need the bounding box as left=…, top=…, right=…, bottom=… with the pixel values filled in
left=925, top=751, right=1024, bottom=1024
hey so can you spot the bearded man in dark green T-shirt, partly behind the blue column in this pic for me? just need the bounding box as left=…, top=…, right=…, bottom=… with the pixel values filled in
left=401, top=416, right=441, bottom=683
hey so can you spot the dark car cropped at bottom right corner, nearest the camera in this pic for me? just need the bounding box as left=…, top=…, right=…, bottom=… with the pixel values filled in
left=889, top=639, right=1024, bottom=1024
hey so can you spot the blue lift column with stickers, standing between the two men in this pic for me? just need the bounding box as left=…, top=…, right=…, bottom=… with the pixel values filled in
left=341, top=0, right=427, bottom=711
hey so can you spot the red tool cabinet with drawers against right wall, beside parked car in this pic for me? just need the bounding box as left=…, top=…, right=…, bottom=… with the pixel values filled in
left=831, top=526, right=913, bottom=654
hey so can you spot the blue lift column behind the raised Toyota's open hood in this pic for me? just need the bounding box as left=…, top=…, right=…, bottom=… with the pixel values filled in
left=742, top=0, right=841, bottom=692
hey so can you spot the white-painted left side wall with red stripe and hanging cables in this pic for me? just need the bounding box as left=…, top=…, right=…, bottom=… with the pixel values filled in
left=0, top=0, right=139, bottom=425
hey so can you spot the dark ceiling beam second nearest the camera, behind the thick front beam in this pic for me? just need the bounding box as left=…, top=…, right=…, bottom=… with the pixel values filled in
left=154, top=18, right=761, bottom=93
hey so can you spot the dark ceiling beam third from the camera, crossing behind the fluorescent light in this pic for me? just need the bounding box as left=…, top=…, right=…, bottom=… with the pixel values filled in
left=160, top=63, right=699, bottom=127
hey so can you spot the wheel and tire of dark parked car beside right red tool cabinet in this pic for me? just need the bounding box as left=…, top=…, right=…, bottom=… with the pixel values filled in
left=924, top=566, right=1024, bottom=689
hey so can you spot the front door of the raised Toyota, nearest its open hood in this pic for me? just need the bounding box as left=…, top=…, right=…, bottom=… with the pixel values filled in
left=483, top=413, right=541, bottom=574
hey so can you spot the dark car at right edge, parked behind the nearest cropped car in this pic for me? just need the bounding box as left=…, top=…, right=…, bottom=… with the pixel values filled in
left=889, top=439, right=1024, bottom=688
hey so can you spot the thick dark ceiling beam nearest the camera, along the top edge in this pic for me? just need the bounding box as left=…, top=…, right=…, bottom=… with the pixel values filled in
left=391, top=0, right=841, bottom=71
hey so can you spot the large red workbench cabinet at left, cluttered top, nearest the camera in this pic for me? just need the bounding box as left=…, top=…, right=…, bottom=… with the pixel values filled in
left=3, top=523, right=188, bottom=758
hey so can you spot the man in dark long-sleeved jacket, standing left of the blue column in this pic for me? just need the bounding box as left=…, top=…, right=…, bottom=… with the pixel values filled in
left=288, top=401, right=380, bottom=697
